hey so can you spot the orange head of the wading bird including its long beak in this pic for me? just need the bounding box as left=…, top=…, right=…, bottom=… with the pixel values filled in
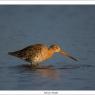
left=50, top=44, right=78, bottom=61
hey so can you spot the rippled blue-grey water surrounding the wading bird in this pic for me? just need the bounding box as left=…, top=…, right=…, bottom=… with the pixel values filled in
left=0, top=6, right=95, bottom=90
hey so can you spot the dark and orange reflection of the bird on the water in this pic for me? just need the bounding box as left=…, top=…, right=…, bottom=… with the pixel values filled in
left=19, top=64, right=59, bottom=79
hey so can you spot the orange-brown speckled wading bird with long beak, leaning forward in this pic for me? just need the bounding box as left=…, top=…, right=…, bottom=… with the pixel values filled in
left=8, top=44, right=78, bottom=66
